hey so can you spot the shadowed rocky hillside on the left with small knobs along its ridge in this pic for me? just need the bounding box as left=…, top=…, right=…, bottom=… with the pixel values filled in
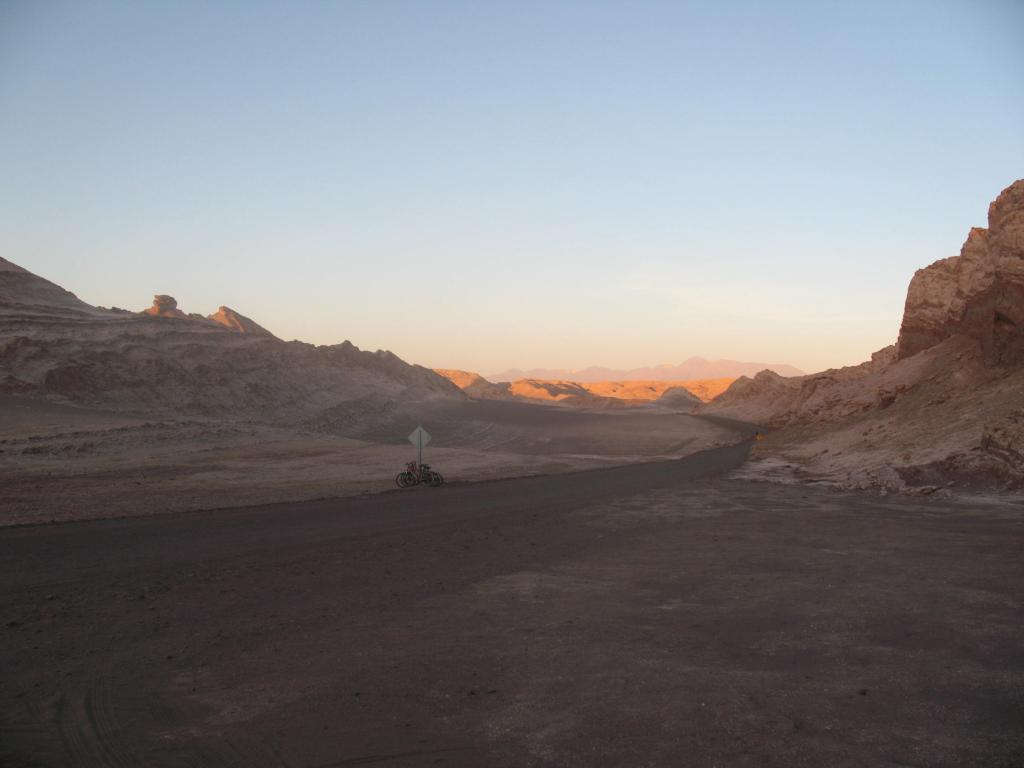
left=0, top=259, right=464, bottom=424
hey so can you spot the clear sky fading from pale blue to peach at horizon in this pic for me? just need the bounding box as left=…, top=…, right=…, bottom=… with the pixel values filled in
left=0, top=0, right=1024, bottom=374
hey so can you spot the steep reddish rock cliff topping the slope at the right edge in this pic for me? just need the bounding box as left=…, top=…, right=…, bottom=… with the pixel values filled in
left=897, top=180, right=1024, bottom=366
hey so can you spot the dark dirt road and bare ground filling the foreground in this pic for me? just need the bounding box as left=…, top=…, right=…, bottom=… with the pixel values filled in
left=0, top=444, right=1024, bottom=768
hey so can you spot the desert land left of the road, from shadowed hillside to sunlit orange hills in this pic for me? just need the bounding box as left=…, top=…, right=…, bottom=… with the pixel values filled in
left=0, top=256, right=753, bottom=524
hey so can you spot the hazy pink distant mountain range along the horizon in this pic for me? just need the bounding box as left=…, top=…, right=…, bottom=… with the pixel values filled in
left=486, top=357, right=804, bottom=382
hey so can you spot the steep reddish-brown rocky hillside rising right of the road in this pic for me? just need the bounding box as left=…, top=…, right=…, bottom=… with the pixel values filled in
left=702, top=180, right=1024, bottom=493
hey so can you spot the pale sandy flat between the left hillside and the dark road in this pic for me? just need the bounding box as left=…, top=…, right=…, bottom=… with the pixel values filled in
left=0, top=396, right=736, bottom=525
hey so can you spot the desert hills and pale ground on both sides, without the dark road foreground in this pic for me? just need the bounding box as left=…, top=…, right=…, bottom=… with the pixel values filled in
left=0, top=182, right=1024, bottom=524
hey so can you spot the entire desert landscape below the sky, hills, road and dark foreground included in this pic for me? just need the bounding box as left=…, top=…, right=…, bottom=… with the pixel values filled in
left=0, top=181, right=1024, bottom=766
